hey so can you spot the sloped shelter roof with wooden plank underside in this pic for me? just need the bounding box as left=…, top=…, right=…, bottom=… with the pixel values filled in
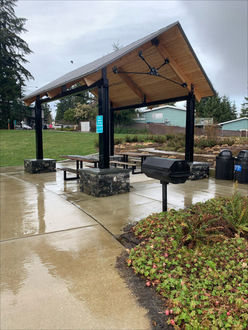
left=23, top=22, right=214, bottom=108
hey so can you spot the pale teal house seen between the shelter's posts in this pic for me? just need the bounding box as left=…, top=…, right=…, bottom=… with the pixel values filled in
left=134, top=105, right=186, bottom=127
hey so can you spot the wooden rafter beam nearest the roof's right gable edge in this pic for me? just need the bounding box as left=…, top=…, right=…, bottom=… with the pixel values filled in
left=155, top=43, right=201, bottom=102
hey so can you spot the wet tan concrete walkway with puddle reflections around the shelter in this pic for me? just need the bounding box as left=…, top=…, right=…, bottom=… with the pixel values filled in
left=0, top=167, right=248, bottom=329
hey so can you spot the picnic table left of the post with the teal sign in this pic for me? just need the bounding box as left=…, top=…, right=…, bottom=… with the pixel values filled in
left=60, top=155, right=99, bottom=181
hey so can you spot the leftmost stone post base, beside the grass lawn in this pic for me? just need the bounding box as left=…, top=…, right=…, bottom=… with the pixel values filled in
left=24, top=158, right=56, bottom=174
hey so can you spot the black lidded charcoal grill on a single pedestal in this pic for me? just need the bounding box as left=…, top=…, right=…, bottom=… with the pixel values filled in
left=141, top=157, right=190, bottom=212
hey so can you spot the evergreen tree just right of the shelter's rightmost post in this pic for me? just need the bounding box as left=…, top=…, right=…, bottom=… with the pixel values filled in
left=195, top=94, right=237, bottom=123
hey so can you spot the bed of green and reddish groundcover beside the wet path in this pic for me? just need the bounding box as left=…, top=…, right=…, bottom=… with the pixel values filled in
left=127, top=194, right=248, bottom=329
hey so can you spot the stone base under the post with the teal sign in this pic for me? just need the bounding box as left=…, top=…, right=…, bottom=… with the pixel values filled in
left=79, top=168, right=130, bottom=197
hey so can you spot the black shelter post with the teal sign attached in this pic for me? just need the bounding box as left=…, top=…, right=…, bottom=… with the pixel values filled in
left=98, top=68, right=110, bottom=169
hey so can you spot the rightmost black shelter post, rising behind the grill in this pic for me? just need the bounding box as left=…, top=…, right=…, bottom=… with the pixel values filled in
left=185, top=86, right=195, bottom=162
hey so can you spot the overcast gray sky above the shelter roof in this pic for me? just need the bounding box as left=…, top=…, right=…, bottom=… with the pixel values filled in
left=16, top=0, right=248, bottom=114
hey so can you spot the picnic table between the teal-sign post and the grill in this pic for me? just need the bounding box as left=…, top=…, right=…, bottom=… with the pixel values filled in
left=110, top=151, right=152, bottom=174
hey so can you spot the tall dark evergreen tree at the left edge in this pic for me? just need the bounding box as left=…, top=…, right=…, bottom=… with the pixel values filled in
left=0, top=0, right=32, bottom=128
